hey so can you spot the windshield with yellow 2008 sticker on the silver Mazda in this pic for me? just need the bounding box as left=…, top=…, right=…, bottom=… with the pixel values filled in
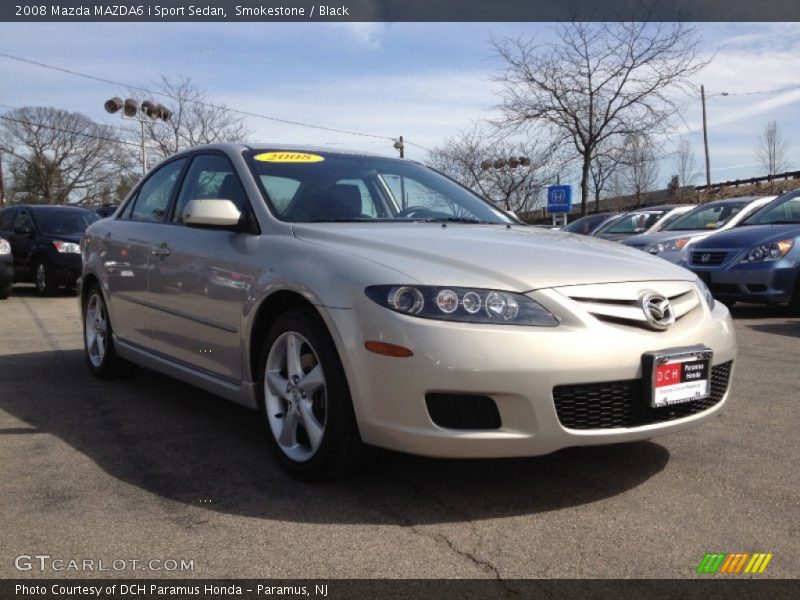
left=248, top=151, right=515, bottom=224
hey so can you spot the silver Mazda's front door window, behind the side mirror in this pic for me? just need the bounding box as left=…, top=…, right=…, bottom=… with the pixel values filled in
left=172, top=154, right=248, bottom=222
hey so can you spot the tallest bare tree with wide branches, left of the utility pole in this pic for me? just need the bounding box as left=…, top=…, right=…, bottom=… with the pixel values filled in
left=495, top=19, right=706, bottom=215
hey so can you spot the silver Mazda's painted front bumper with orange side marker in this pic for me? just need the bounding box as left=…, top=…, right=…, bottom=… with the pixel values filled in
left=329, top=298, right=736, bottom=458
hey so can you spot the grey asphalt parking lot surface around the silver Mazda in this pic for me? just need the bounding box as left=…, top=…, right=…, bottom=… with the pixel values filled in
left=0, top=286, right=800, bottom=579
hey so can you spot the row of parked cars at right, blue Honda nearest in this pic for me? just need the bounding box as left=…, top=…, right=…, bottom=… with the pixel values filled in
left=564, top=190, right=800, bottom=311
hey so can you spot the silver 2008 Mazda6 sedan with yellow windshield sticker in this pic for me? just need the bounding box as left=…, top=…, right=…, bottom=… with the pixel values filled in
left=80, top=144, right=736, bottom=478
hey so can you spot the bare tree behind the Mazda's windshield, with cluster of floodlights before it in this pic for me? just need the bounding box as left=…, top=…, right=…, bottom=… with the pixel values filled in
left=428, top=126, right=553, bottom=215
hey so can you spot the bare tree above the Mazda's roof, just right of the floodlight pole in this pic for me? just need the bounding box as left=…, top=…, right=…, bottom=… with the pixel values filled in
left=138, top=77, right=250, bottom=158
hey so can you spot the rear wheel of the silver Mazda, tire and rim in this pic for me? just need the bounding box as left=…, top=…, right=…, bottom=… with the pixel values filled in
left=83, top=284, right=136, bottom=379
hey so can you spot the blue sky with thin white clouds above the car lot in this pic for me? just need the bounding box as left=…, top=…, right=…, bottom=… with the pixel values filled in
left=0, top=23, right=800, bottom=190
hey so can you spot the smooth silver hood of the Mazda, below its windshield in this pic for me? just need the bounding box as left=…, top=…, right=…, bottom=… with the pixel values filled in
left=293, top=223, right=695, bottom=291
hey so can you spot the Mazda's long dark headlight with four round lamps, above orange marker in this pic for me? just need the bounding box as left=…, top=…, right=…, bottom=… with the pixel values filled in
left=364, top=285, right=558, bottom=327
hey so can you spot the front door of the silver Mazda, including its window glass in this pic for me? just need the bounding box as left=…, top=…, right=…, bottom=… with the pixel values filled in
left=145, top=152, right=257, bottom=382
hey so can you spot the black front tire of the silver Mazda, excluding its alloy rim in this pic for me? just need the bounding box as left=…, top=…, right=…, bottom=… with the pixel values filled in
left=258, top=308, right=371, bottom=481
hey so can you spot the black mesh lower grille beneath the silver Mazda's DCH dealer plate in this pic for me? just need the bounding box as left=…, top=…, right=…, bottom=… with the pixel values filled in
left=553, top=361, right=733, bottom=429
